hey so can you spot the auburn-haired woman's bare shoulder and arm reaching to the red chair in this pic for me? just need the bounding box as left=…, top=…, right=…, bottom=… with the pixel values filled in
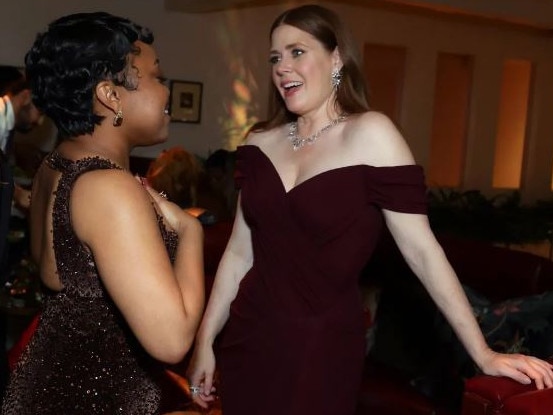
left=351, top=112, right=553, bottom=388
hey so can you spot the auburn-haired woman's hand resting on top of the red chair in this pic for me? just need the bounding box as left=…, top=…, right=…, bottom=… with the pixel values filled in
left=481, top=350, right=553, bottom=389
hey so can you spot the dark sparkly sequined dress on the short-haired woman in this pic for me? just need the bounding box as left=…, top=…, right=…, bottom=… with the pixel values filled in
left=2, top=153, right=177, bottom=415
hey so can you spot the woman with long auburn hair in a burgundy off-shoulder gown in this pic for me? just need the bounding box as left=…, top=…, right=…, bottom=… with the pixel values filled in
left=188, top=5, right=553, bottom=415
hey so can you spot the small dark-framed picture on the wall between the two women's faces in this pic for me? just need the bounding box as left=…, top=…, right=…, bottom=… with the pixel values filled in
left=169, top=80, right=203, bottom=123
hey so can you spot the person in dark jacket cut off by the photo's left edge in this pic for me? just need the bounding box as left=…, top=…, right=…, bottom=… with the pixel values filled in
left=0, top=66, right=41, bottom=402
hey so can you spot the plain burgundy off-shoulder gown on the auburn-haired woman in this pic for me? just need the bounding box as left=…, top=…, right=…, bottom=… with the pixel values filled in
left=218, top=145, right=426, bottom=415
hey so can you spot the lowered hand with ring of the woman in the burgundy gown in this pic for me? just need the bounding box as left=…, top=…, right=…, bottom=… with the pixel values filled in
left=186, top=344, right=215, bottom=409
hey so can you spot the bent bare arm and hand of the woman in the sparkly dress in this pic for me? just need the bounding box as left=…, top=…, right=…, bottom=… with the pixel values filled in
left=70, top=170, right=204, bottom=363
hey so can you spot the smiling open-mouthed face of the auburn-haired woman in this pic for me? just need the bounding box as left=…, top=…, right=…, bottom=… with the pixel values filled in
left=269, top=25, right=342, bottom=115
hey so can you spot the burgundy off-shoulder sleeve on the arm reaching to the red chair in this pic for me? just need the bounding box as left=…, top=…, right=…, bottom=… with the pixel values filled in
left=368, top=165, right=427, bottom=214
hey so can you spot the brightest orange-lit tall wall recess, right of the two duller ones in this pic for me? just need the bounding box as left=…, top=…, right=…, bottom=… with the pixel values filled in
left=492, top=59, right=532, bottom=189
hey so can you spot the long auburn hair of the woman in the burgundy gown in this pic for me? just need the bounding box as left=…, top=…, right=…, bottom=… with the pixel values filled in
left=251, top=5, right=370, bottom=132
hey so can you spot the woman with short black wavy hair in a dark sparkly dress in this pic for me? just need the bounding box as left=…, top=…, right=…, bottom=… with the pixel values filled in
left=1, top=12, right=204, bottom=415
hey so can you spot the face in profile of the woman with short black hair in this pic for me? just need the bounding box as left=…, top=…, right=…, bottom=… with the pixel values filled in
left=119, top=42, right=170, bottom=145
